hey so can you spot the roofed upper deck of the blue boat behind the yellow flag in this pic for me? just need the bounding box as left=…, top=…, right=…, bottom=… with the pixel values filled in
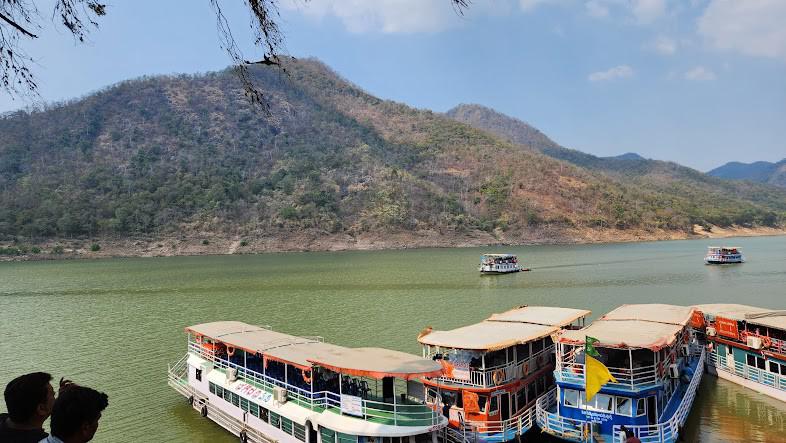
left=554, top=304, right=701, bottom=391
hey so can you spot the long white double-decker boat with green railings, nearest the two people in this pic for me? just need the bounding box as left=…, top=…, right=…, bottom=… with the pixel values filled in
left=168, top=321, right=447, bottom=443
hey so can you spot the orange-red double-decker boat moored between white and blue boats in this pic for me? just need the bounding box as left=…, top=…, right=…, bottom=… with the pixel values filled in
left=418, top=306, right=590, bottom=443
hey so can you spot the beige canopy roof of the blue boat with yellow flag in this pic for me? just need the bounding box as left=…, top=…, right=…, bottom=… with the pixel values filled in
left=559, top=304, right=695, bottom=351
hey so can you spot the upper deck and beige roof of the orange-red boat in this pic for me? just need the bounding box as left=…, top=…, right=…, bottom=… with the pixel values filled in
left=418, top=306, right=590, bottom=389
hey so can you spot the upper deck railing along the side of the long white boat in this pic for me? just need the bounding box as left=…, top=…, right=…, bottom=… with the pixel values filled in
left=189, top=343, right=442, bottom=426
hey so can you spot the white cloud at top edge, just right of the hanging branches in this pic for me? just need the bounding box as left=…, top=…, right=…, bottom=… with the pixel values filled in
left=281, top=0, right=461, bottom=34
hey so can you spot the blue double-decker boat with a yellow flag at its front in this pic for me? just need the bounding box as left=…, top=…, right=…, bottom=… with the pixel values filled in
left=536, top=304, right=705, bottom=443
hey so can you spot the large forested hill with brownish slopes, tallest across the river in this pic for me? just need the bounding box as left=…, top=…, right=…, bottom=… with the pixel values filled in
left=0, top=60, right=786, bottom=253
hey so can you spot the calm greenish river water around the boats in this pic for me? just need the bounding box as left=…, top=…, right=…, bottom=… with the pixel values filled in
left=0, top=237, right=786, bottom=442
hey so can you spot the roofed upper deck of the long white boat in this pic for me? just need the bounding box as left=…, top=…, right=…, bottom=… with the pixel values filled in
left=181, top=322, right=447, bottom=436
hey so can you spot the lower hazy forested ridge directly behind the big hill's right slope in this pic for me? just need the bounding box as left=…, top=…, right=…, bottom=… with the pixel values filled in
left=447, top=104, right=786, bottom=226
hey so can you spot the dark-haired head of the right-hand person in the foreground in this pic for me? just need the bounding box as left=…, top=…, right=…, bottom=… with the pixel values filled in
left=51, top=385, right=109, bottom=442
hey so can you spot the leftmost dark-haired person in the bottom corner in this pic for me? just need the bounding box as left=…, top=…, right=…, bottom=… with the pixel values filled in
left=0, top=372, right=55, bottom=443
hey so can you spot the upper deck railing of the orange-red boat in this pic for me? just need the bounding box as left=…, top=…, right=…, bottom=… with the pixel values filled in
left=434, top=346, right=554, bottom=388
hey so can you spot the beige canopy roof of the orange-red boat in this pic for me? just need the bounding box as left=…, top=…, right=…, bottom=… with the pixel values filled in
left=418, top=306, right=590, bottom=351
